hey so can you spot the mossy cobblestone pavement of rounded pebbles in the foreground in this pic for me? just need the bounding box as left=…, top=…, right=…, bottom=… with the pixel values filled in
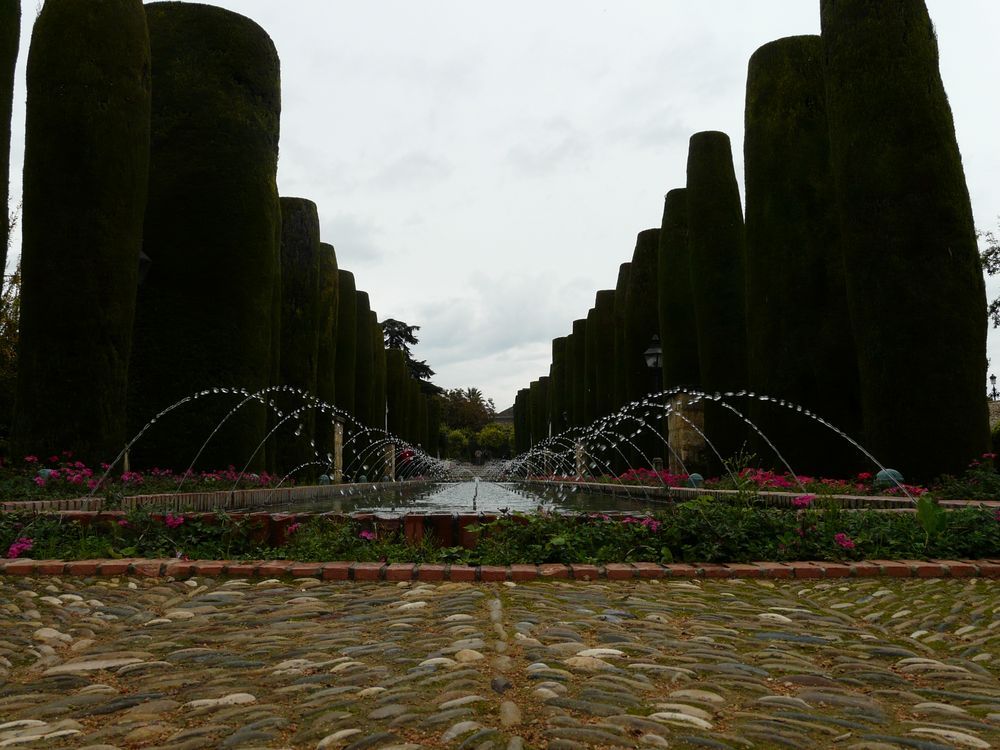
left=0, top=576, right=1000, bottom=750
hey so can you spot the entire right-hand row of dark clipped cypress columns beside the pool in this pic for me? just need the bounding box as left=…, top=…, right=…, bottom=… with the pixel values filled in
left=515, top=0, right=989, bottom=480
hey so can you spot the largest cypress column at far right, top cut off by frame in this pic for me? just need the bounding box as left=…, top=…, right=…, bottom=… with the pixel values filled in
left=821, top=0, right=989, bottom=479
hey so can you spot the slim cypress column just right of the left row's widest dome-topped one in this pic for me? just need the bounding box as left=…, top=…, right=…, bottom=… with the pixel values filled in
left=275, top=198, right=320, bottom=476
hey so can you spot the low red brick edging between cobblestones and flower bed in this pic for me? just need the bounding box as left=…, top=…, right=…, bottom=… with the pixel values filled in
left=0, top=559, right=1000, bottom=583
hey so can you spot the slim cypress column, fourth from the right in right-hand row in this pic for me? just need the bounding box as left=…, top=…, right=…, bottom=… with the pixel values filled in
left=657, top=188, right=701, bottom=388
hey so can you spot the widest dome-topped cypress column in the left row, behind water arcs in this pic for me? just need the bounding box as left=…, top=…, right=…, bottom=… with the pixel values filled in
left=129, top=3, right=281, bottom=468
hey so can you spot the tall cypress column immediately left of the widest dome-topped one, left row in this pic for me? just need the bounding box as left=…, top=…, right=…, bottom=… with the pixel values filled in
left=15, top=0, right=150, bottom=463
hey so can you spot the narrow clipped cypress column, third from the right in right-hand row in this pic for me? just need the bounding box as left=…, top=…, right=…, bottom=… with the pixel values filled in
left=687, top=131, right=747, bottom=473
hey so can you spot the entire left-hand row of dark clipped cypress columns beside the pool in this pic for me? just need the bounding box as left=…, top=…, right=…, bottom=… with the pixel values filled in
left=0, top=0, right=438, bottom=474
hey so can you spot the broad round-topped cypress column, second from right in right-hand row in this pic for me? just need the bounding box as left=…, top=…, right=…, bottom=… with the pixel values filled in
left=743, top=36, right=870, bottom=476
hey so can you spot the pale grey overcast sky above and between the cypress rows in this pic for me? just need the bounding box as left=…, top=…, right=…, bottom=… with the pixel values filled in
left=5, top=0, right=1000, bottom=409
